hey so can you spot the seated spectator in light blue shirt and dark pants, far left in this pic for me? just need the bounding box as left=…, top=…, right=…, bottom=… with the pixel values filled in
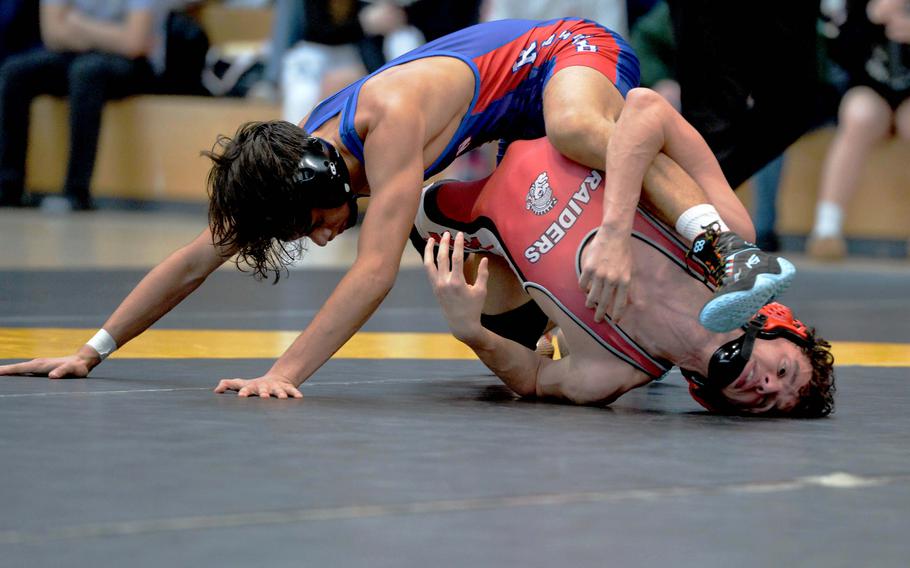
left=0, top=0, right=173, bottom=210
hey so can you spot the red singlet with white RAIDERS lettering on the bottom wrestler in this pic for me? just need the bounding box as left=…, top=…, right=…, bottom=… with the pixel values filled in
left=414, top=138, right=713, bottom=378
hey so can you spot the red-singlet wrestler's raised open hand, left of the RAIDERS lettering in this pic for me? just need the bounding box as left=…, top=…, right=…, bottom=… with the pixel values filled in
left=423, top=232, right=489, bottom=344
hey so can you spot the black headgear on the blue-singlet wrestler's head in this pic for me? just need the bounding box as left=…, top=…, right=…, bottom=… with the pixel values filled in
left=293, top=136, right=357, bottom=227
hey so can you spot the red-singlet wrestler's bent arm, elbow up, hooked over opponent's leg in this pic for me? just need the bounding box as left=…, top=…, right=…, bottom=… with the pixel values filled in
left=579, top=89, right=754, bottom=321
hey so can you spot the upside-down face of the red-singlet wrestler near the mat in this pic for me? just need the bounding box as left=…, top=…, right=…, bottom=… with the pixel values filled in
left=721, top=339, right=812, bottom=414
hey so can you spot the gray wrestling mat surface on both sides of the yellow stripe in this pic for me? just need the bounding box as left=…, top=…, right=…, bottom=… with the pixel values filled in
left=0, top=263, right=910, bottom=568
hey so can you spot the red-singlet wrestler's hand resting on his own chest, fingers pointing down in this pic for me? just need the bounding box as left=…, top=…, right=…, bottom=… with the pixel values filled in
left=578, top=227, right=632, bottom=322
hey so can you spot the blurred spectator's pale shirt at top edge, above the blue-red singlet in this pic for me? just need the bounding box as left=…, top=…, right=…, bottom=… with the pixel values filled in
left=484, top=0, right=629, bottom=37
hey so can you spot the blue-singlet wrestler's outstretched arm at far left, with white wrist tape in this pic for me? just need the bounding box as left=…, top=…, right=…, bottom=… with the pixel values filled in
left=0, top=229, right=233, bottom=378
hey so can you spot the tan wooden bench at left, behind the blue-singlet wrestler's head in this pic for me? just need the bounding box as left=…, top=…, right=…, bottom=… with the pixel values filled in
left=26, top=95, right=281, bottom=202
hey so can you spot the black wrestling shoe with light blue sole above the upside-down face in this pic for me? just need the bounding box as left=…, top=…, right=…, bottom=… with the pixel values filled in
left=689, top=223, right=796, bottom=332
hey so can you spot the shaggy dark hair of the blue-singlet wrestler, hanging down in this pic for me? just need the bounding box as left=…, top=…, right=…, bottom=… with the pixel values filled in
left=202, top=120, right=312, bottom=283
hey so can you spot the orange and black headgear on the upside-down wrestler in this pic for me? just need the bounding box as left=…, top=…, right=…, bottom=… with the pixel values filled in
left=681, top=302, right=811, bottom=400
